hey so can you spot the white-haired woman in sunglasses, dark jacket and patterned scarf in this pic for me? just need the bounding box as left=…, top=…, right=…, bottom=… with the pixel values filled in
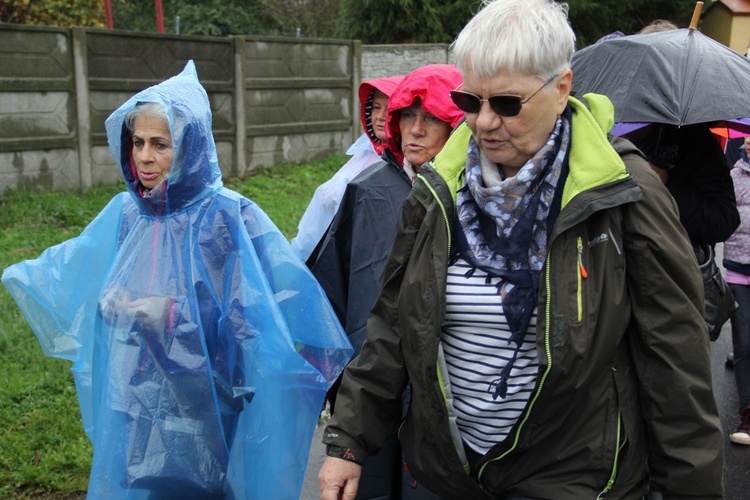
left=319, top=0, right=723, bottom=499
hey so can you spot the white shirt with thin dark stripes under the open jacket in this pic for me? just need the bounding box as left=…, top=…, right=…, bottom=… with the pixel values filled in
left=442, top=260, right=539, bottom=454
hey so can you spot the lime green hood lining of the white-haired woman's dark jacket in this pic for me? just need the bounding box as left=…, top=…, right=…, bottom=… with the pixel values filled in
left=432, top=94, right=628, bottom=207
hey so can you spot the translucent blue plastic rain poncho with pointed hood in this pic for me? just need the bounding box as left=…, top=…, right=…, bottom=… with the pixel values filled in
left=2, top=62, right=352, bottom=499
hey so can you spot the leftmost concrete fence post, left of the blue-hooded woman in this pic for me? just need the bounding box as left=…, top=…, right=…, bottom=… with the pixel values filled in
left=72, top=28, right=92, bottom=189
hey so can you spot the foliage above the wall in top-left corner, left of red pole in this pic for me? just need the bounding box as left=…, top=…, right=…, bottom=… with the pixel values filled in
left=0, top=0, right=104, bottom=28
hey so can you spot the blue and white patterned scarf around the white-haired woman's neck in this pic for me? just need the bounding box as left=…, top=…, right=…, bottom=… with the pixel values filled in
left=456, top=116, right=570, bottom=398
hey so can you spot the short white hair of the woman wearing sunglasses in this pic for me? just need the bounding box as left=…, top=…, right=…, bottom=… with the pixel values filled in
left=451, top=0, right=576, bottom=80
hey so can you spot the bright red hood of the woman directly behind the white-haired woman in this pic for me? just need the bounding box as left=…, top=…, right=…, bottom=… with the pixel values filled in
left=386, top=64, right=464, bottom=165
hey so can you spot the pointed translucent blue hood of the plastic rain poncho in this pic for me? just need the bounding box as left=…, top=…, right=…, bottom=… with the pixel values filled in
left=105, top=61, right=222, bottom=215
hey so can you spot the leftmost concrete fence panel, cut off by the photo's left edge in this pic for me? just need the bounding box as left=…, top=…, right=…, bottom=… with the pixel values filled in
left=0, top=26, right=80, bottom=193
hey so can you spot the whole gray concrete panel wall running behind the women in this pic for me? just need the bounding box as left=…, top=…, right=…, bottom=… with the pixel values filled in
left=0, top=24, right=448, bottom=197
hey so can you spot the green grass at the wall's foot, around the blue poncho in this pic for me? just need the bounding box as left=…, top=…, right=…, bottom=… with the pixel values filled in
left=0, top=155, right=347, bottom=499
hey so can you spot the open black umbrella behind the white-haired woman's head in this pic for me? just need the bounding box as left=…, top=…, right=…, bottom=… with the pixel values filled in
left=572, top=28, right=750, bottom=125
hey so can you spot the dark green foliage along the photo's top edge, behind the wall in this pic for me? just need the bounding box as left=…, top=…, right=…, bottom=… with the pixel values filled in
left=0, top=0, right=708, bottom=48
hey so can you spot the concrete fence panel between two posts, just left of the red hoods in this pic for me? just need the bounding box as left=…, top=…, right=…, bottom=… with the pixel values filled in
left=244, top=38, right=356, bottom=172
